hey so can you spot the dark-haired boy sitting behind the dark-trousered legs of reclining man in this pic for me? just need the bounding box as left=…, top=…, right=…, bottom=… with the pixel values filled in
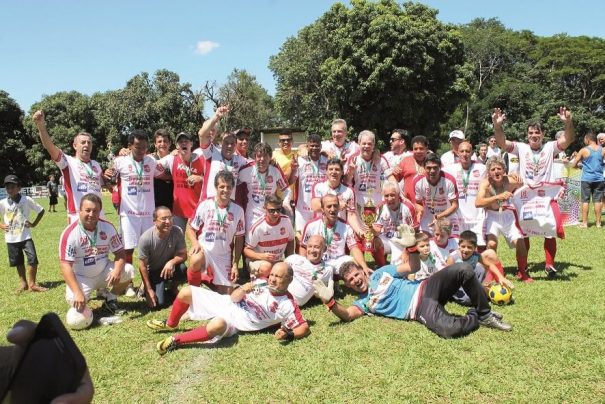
left=447, top=230, right=514, bottom=305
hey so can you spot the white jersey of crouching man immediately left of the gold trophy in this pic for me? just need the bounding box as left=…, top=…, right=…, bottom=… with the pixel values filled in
left=300, top=217, right=357, bottom=261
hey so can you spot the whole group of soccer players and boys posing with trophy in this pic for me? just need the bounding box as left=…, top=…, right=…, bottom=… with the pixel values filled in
left=0, top=106, right=603, bottom=354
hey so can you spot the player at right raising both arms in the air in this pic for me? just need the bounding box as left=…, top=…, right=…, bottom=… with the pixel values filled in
left=492, top=107, right=575, bottom=277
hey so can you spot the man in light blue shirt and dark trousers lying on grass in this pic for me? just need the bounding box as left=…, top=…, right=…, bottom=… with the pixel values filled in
left=314, top=224, right=512, bottom=338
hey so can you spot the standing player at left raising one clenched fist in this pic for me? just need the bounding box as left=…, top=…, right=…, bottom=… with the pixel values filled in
left=32, top=110, right=104, bottom=223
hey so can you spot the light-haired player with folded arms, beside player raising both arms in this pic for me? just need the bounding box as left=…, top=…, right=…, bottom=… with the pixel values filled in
left=475, top=157, right=533, bottom=282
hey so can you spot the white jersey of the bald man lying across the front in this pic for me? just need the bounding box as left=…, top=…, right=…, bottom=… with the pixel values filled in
left=233, top=281, right=307, bottom=331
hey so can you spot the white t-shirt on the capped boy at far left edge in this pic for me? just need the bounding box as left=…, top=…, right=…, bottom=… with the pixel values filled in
left=0, top=195, right=44, bottom=243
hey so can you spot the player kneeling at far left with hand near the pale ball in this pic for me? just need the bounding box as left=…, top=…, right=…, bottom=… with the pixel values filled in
left=59, top=194, right=134, bottom=320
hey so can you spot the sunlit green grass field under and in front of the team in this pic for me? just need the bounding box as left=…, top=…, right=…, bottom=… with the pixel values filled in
left=0, top=199, right=605, bottom=403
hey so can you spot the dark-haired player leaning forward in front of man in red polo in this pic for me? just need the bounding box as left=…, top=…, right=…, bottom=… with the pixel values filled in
left=414, top=153, right=458, bottom=236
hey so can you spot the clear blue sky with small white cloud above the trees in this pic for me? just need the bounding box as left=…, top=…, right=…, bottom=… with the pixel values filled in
left=0, top=0, right=605, bottom=112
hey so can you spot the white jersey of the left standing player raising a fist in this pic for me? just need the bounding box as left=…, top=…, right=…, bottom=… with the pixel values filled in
left=55, top=151, right=103, bottom=214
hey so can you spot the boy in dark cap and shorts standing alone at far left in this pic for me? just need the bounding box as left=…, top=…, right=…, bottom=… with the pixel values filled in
left=0, top=175, right=48, bottom=293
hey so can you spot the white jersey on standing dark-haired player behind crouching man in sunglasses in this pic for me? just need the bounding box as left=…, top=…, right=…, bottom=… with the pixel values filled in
left=238, top=163, right=288, bottom=229
